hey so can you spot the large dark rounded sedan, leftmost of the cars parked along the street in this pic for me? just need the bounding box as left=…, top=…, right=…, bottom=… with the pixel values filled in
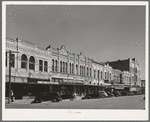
left=33, top=92, right=62, bottom=103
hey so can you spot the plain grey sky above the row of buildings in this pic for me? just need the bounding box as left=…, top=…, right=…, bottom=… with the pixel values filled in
left=6, top=5, right=145, bottom=79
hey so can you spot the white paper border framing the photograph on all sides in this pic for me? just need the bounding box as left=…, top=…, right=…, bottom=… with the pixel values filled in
left=2, top=1, right=149, bottom=121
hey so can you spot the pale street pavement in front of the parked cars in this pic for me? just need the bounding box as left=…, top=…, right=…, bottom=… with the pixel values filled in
left=5, top=95, right=145, bottom=110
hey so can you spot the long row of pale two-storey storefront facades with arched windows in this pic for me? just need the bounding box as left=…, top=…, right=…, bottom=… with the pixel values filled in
left=5, top=38, right=140, bottom=98
